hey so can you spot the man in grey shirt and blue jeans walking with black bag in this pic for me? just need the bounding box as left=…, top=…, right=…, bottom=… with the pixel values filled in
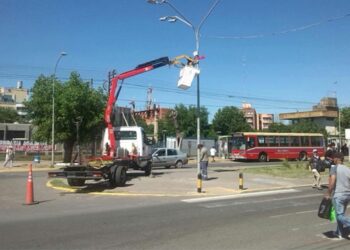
left=325, top=153, right=350, bottom=238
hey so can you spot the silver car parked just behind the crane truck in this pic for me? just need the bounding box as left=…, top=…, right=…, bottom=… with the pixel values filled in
left=152, top=148, right=188, bottom=168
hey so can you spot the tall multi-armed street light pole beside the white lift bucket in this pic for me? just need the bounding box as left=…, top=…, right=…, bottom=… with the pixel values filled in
left=147, top=0, right=220, bottom=193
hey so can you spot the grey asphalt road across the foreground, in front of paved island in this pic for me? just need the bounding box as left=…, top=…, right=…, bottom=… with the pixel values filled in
left=0, top=174, right=349, bottom=249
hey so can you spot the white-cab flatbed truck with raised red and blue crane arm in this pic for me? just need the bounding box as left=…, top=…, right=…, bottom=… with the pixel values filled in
left=48, top=55, right=197, bottom=187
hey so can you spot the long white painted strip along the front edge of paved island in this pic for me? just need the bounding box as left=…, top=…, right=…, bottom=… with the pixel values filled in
left=182, top=189, right=300, bottom=203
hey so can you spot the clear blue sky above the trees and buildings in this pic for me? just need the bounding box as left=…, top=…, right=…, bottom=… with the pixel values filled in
left=0, top=0, right=350, bottom=121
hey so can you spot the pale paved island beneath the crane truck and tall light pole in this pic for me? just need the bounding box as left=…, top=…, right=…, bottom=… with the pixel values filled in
left=34, top=161, right=318, bottom=197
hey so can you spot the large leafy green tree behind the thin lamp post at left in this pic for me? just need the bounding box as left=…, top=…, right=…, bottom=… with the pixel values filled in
left=26, top=72, right=106, bottom=162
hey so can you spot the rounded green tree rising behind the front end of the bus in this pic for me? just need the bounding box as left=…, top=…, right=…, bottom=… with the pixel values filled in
left=212, top=106, right=251, bottom=135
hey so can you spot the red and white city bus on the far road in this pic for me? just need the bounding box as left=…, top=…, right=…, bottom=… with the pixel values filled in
left=231, top=132, right=325, bottom=162
